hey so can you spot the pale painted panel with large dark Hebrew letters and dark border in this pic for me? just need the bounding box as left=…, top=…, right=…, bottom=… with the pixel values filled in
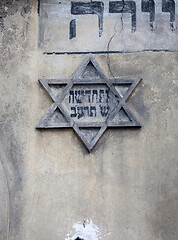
left=39, top=0, right=178, bottom=54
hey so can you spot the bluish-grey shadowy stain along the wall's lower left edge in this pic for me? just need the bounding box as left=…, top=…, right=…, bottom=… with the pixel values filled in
left=0, top=125, right=22, bottom=240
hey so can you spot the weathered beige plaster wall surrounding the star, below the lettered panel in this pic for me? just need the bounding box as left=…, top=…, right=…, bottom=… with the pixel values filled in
left=0, top=0, right=178, bottom=240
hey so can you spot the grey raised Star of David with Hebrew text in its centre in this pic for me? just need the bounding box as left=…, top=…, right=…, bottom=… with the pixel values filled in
left=37, top=56, right=141, bottom=151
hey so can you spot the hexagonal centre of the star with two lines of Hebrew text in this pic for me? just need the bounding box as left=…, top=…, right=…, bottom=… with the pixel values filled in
left=66, top=84, right=116, bottom=123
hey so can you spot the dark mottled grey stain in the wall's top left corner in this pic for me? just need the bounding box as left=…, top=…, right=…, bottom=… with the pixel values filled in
left=0, top=0, right=31, bottom=62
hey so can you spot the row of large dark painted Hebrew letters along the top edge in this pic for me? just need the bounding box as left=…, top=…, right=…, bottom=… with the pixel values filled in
left=70, top=0, right=175, bottom=39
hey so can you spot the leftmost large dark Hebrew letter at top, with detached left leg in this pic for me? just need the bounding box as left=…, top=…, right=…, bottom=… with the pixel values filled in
left=70, top=2, right=104, bottom=39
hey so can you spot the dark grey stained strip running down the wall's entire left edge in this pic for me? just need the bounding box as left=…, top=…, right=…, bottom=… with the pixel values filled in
left=0, top=0, right=31, bottom=240
